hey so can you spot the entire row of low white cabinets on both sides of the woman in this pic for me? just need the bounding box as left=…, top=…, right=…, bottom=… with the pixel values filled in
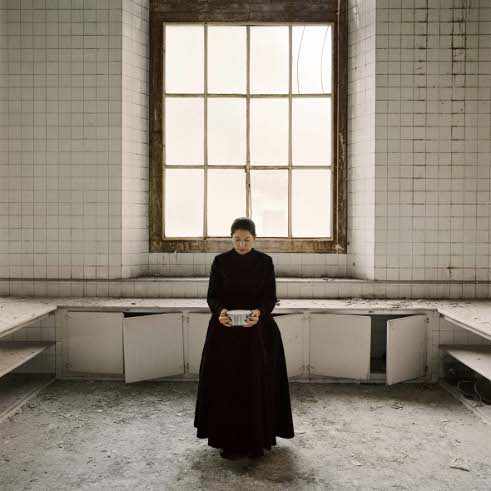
left=63, top=311, right=428, bottom=385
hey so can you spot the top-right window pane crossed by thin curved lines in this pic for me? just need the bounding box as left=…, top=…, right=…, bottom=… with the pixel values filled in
left=292, top=26, right=332, bottom=94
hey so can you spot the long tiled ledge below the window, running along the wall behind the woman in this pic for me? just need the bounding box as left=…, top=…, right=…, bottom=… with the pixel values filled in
left=0, top=277, right=491, bottom=299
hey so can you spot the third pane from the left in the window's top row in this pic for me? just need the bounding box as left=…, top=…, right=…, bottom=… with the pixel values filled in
left=250, top=26, right=289, bottom=94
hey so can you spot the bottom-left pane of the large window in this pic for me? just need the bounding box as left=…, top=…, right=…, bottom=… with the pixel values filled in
left=164, top=169, right=204, bottom=237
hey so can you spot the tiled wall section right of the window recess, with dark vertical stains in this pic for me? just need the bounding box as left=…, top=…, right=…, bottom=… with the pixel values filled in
left=375, top=0, right=491, bottom=281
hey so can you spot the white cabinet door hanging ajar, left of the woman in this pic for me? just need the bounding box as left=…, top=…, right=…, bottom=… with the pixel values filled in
left=123, top=312, right=184, bottom=383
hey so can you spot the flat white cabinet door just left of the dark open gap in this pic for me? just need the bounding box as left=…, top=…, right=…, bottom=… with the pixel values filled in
left=310, top=313, right=371, bottom=380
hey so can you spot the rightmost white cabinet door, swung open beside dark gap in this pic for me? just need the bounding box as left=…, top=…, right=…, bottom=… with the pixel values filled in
left=387, top=315, right=427, bottom=385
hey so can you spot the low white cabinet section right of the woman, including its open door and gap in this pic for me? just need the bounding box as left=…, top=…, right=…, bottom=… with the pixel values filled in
left=275, top=313, right=428, bottom=385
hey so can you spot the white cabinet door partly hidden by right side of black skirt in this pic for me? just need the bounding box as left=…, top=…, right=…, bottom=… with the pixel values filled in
left=274, top=314, right=305, bottom=378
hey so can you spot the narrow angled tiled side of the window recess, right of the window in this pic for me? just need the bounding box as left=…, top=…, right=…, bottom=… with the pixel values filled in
left=348, top=0, right=375, bottom=278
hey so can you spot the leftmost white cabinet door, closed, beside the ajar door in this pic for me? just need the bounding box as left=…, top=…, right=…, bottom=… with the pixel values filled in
left=64, top=311, right=123, bottom=374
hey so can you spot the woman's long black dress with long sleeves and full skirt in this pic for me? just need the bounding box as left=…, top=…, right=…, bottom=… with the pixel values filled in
left=194, top=248, right=294, bottom=450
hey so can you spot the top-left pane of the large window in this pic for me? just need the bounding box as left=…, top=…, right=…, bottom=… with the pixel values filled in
left=164, top=24, right=204, bottom=94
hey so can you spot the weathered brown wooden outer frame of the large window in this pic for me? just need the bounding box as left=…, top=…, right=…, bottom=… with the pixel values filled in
left=148, top=0, right=348, bottom=253
